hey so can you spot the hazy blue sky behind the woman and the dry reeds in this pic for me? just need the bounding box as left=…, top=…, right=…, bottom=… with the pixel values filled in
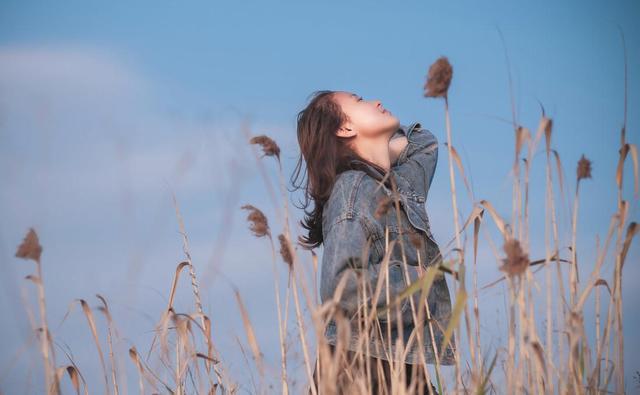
left=0, top=1, right=640, bottom=393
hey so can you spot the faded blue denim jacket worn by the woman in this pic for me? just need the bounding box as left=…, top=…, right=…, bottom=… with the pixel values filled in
left=320, top=122, right=456, bottom=365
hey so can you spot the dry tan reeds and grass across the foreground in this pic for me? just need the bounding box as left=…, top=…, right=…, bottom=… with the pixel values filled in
left=2, top=51, right=640, bottom=395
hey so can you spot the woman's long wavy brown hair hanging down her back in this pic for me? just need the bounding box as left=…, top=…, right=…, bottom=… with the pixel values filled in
left=291, top=90, right=382, bottom=249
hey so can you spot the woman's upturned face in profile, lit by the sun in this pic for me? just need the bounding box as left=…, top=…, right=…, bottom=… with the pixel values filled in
left=333, top=91, right=400, bottom=138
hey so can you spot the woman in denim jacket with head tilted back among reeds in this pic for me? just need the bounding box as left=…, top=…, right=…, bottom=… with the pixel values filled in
left=292, top=91, right=455, bottom=393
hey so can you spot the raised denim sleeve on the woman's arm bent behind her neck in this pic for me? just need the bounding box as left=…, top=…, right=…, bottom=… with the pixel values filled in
left=392, top=123, right=438, bottom=199
